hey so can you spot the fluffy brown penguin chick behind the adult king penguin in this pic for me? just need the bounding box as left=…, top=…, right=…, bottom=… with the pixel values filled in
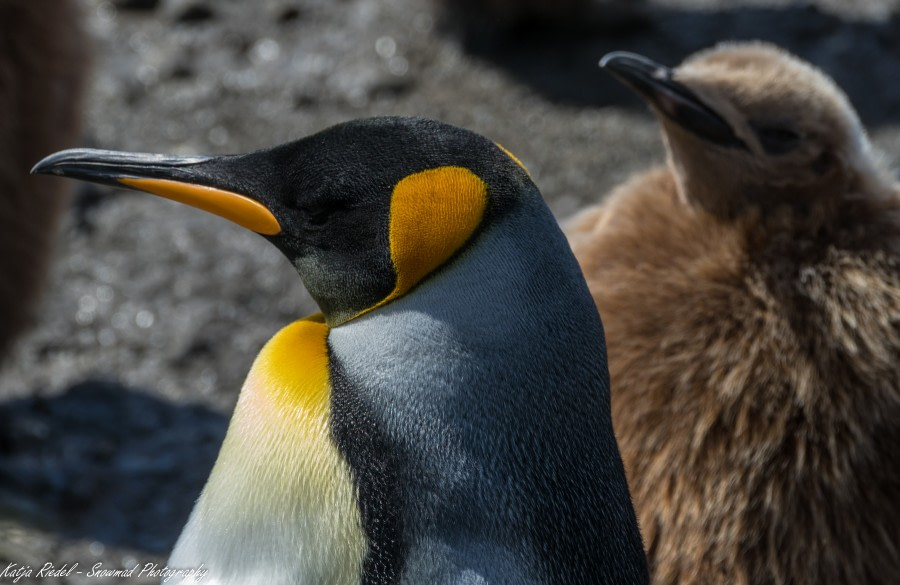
left=567, top=43, right=900, bottom=585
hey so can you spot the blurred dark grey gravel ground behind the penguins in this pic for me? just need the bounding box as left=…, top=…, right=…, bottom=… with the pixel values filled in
left=0, top=0, right=900, bottom=583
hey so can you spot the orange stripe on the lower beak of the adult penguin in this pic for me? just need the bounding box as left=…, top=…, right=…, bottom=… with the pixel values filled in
left=118, top=177, right=281, bottom=236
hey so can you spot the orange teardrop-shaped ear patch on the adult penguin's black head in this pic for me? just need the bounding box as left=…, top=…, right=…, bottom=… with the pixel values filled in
left=360, top=166, right=488, bottom=314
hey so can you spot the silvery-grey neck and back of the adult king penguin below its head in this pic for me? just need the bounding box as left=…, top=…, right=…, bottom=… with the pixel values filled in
left=329, top=197, right=646, bottom=583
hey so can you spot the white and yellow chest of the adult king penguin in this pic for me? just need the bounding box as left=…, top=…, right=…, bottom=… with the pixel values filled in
left=169, top=321, right=366, bottom=585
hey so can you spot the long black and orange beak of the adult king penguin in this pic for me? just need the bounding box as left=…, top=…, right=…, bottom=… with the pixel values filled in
left=31, top=148, right=281, bottom=236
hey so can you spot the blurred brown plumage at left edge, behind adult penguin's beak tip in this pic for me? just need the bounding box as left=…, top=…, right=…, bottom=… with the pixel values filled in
left=0, top=0, right=88, bottom=357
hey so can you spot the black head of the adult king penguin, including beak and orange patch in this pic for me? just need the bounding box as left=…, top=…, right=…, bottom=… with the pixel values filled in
left=32, top=118, right=536, bottom=326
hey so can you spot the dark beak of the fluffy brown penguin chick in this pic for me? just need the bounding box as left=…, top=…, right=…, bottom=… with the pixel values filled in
left=600, top=51, right=747, bottom=150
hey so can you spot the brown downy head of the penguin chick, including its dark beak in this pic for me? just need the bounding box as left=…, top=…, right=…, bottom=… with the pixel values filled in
left=601, top=42, right=877, bottom=215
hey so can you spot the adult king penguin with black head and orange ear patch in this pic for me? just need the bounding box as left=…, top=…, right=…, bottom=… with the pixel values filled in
left=34, top=118, right=648, bottom=585
